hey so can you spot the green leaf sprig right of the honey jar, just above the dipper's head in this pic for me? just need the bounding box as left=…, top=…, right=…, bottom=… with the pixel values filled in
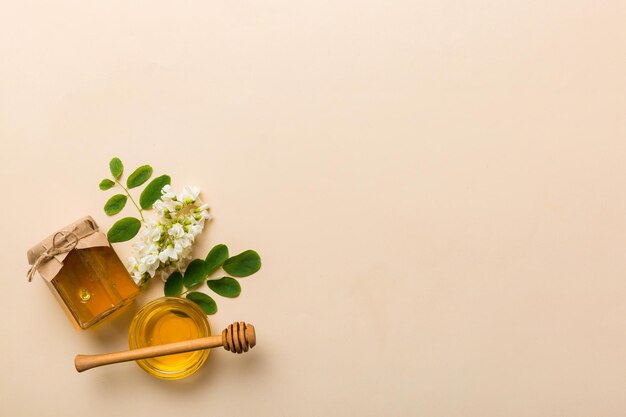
left=163, top=244, right=261, bottom=314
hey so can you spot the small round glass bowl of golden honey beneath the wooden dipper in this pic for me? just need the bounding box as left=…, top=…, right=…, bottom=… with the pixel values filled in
left=128, top=297, right=211, bottom=379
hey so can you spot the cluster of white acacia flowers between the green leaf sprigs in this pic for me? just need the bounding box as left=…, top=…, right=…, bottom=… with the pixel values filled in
left=128, top=185, right=211, bottom=285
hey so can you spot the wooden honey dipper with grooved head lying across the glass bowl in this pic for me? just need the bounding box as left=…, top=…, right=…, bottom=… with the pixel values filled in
left=74, top=321, right=256, bottom=372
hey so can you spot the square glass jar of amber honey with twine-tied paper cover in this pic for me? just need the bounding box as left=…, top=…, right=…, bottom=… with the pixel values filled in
left=28, top=217, right=139, bottom=329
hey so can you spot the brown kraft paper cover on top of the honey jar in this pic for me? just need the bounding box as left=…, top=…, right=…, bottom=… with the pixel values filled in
left=26, top=216, right=110, bottom=282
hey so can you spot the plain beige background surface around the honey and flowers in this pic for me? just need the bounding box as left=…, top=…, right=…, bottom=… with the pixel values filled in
left=0, top=0, right=626, bottom=417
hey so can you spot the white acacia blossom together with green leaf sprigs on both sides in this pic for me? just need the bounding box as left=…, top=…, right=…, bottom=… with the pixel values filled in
left=100, top=158, right=261, bottom=308
